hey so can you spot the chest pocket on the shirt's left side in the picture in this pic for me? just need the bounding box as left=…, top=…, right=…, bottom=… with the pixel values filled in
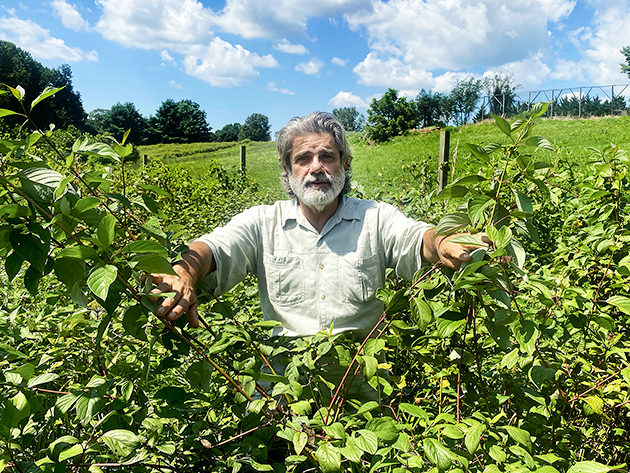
left=264, top=255, right=305, bottom=305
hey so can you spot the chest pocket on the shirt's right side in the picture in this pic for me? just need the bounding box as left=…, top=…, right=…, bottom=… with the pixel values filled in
left=341, top=255, right=382, bottom=303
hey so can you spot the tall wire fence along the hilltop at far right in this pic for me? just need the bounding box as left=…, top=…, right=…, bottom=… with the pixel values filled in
left=476, top=84, right=630, bottom=119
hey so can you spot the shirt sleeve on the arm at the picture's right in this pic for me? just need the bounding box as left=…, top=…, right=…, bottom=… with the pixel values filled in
left=379, top=203, right=433, bottom=281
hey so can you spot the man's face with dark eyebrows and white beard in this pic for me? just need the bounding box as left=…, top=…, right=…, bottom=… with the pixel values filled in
left=287, top=133, right=346, bottom=211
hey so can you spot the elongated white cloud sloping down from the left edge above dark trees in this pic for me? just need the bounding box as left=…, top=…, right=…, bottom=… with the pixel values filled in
left=0, top=17, right=98, bottom=62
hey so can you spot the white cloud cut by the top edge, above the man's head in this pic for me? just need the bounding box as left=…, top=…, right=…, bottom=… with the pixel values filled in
left=213, top=0, right=372, bottom=39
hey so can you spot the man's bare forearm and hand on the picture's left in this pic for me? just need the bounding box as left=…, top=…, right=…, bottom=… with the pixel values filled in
left=152, top=241, right=215, bottom=327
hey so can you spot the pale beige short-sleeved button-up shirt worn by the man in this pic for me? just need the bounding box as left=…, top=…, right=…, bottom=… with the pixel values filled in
left=198, top=196, right=431, bottom=337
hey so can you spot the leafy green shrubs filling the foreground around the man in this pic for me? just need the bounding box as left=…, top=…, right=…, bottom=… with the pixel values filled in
left=0, top=88, right=630, bottom=473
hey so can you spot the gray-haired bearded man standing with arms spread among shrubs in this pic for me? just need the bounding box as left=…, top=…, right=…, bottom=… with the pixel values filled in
left=153, top=112, right=486, bottom=339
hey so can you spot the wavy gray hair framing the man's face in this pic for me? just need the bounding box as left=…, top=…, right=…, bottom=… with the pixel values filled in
left=276, top=112, right=352, bottom=198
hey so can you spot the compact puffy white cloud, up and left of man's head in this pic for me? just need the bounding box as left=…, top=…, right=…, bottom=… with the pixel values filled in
left=184, top=38, right=278, bottom=87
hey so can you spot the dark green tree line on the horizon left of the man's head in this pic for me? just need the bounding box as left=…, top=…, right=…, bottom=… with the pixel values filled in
left=0, top=41, right=271, bottom=144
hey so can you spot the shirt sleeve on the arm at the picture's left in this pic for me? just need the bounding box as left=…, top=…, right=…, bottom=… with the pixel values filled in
left=196, top=207, right=261, bottom=295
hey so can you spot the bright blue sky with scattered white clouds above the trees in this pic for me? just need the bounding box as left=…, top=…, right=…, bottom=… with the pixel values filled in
left=0, top=0, right=630, bottom=132
